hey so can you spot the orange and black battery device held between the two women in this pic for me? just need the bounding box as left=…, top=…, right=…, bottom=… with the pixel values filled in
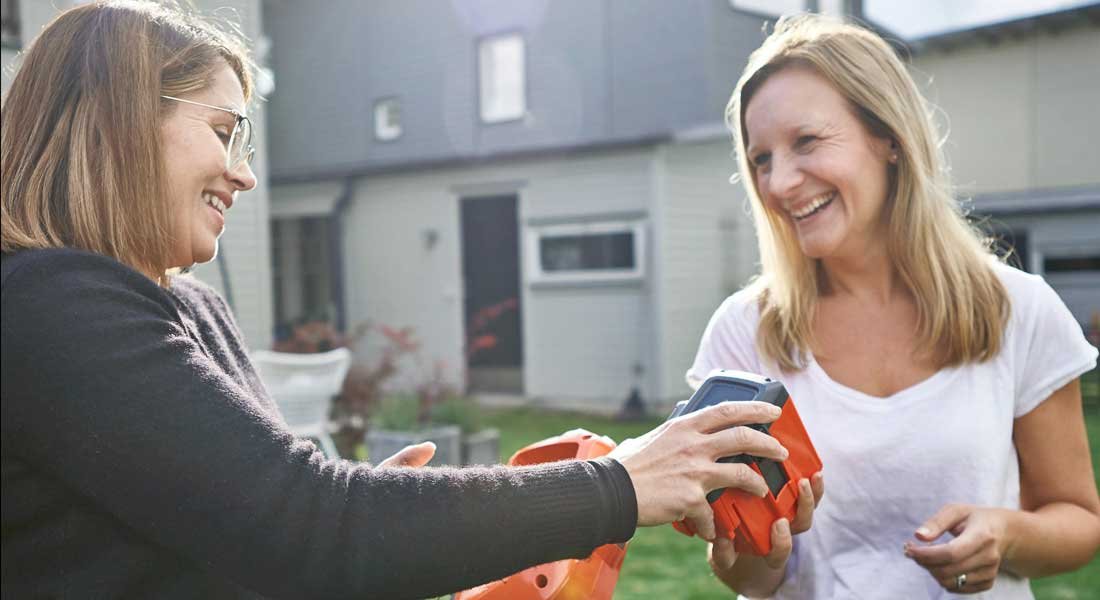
left=669, top=370, right=822, bottom=556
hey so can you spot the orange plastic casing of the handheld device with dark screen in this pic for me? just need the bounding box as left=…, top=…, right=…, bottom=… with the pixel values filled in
left=673, top=371, right=822, bottom=556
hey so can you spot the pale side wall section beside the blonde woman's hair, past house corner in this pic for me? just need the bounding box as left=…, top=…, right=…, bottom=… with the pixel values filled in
left=655, top=139, right=758, bottom=402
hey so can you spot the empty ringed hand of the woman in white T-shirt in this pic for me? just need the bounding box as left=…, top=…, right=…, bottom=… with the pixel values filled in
left=905, top=504, right=1008, bottom=593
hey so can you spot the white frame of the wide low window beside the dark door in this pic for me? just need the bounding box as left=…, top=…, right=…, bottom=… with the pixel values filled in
left=525, top=220, right=647, bottom=283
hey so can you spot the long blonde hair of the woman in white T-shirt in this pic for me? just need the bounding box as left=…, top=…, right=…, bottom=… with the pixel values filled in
left=726, top=14, right=1010, bottom=370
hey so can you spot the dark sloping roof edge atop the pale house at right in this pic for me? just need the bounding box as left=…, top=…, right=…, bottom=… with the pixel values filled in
left=905, top=2, right=1100, bottom=53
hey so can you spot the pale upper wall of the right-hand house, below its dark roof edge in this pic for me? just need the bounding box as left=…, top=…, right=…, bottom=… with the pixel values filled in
left=914, top=26, right=1100, bottom=195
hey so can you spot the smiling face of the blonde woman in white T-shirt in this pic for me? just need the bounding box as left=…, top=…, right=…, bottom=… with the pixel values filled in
left=745, top=66, right=897, bottom=259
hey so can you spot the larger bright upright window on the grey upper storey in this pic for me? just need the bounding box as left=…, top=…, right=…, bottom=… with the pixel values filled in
left=477, top=33, right=527, bottom=123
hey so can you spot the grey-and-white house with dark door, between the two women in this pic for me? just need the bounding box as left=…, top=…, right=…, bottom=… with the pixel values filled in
left=265, top=0, right=800, bottom=411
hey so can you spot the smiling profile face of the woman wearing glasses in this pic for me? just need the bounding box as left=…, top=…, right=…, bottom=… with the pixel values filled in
left=161, top=63, right=256, bottom=268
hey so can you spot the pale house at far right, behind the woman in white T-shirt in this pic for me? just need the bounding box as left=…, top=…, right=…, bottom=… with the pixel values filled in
left=910, top=7, right=1100, bottom=327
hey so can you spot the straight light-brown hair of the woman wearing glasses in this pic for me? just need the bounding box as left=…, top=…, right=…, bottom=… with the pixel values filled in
left=0, top=1, right=252, bottom=283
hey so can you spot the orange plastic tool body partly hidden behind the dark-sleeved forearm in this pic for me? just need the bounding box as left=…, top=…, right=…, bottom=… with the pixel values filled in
left=454, top=429, right=626, bottom=600
